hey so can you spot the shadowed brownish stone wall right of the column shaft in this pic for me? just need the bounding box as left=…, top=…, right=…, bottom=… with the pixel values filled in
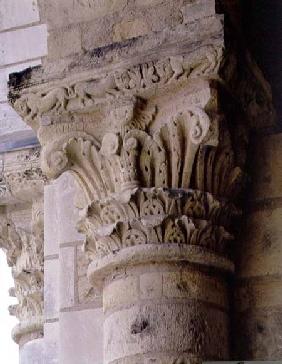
left=234, top=134, right=282, bottom=360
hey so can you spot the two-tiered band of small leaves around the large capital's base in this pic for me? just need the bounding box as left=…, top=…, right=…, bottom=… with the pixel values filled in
left=79, top=188, right=236, bottom=257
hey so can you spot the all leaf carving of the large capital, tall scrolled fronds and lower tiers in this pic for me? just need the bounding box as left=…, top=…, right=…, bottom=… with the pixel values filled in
left=38, top=95, right=243, bottom=257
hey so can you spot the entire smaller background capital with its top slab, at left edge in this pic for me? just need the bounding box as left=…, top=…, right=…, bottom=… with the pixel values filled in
left=0, top=149, right=44, bottom=348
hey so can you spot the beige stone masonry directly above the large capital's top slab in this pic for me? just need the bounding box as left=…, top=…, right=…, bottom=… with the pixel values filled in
left=41, top=0, right=192, bottom=62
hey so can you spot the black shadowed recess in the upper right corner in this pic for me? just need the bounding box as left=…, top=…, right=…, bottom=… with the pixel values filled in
left=241, top=0, right=282, bottom=132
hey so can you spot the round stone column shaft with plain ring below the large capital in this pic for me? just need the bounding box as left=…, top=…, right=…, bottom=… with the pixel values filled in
left=89, top=244, right=232, bottom=364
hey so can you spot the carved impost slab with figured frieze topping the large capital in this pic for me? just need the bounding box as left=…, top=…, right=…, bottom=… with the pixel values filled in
left=9, top=20, right=275, bottom=130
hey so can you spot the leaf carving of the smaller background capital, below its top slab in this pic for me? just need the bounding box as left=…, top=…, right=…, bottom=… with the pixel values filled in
left=0, top=201, right=43, bottom=342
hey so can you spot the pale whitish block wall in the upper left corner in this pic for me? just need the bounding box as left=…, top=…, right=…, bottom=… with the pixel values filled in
left=0, top=0, right=47, bottom=142
